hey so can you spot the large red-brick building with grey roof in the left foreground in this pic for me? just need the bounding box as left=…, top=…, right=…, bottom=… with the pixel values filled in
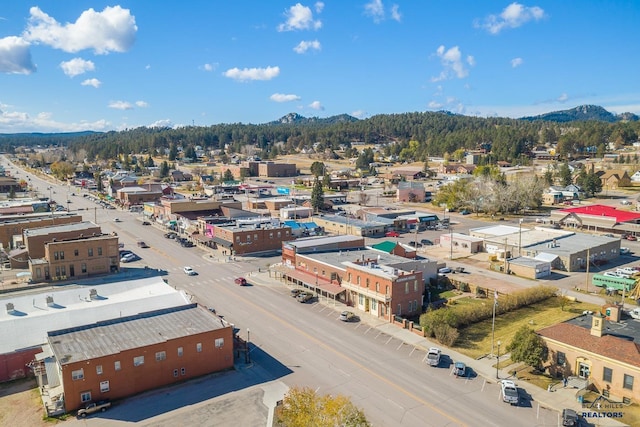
left=41, top=304, right=233, bottom=412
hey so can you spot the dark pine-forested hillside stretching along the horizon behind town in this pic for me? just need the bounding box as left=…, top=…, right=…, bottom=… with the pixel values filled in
left=0, top=108, right=640, bottom=162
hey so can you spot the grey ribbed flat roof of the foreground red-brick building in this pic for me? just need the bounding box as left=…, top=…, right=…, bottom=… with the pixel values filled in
left=48, top=304, right=226, bottom=365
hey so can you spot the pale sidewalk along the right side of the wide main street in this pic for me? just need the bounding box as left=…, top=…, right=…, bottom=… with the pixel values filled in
left=249, top=271, right=626, bottom=427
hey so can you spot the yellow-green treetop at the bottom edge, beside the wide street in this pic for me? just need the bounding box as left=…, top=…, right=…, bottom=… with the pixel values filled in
left=275, top=387, right=370, bottom=427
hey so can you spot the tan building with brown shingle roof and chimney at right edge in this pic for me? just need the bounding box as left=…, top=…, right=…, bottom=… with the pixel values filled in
left=538, top=314, right=640, bottom=403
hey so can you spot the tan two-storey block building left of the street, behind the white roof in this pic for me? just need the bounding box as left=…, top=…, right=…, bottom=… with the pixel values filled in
left=29, top=234, right=120, bottom=281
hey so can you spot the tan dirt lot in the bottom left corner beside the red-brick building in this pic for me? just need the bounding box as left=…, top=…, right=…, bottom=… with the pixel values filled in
left=0, top=379, right=57, bottom=427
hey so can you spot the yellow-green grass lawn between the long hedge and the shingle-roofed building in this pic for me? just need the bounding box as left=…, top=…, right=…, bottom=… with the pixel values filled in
left=453, top=297, right=599, bottom=359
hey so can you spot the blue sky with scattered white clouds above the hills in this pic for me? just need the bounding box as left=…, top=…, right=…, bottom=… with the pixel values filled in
left=0, top=0, right=640, bottom=133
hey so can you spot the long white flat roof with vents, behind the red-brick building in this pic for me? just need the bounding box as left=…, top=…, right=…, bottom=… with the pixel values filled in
left=0, top=277, right=190, bottom=354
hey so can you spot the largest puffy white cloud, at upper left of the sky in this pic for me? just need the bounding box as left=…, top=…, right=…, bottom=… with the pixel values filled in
left=23, top=6, right=138, bottom=54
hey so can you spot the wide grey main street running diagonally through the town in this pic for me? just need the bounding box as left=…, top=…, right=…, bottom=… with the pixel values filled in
left=6, top=159, right=557, bottom=426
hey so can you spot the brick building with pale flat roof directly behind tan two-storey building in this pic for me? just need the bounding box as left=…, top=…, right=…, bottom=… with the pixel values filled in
left=22, top=219, right=102, bottom=259
